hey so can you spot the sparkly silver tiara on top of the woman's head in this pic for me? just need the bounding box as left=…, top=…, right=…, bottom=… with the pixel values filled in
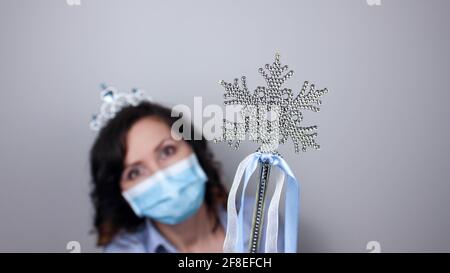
left=89, top=84, right=152, bottom=131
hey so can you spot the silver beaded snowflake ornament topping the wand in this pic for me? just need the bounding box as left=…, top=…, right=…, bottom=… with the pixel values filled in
left=215, top=53, right=328, bottom=154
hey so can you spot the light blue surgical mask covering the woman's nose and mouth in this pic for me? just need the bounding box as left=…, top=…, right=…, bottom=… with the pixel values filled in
left=122, top=153, right=207, bottom=225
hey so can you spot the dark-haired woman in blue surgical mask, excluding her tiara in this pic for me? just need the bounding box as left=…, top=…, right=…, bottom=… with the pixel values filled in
left=90, top=102, right=227, bottom=252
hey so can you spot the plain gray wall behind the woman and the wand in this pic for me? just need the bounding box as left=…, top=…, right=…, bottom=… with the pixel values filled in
left=0, top=0, right=450, bottom=252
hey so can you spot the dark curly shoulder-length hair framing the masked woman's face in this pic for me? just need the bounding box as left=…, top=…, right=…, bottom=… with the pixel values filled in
left=90, top=102, right=227, bottom=246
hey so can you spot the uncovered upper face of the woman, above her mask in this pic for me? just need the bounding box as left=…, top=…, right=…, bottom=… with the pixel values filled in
left=120, top=117, right=192, bottom=191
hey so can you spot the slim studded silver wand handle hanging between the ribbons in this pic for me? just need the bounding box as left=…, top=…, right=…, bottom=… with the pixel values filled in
left=249, top=162, right=271, bottom=253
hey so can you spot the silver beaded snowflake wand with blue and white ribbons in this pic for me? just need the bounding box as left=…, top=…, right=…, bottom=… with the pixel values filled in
left=215, top=53, right=328, bottom=253
